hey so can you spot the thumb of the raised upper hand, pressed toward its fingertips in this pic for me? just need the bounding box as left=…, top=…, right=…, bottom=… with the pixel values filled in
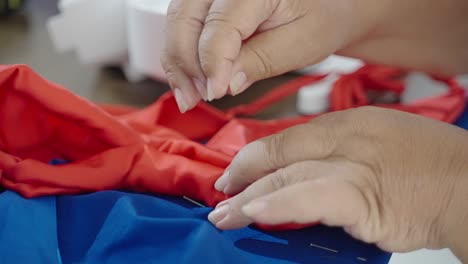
left=229, top=18, right=337, bottom=95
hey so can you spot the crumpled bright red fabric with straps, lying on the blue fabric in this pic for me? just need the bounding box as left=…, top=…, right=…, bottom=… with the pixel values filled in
left=0, top=65, right=465, bottom=212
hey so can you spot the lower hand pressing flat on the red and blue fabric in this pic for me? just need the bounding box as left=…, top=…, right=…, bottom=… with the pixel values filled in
left=209, top=107, right=468, bottom=261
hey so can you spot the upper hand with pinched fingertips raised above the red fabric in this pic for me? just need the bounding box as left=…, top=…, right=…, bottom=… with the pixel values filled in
left=162, top=0, right=468, bottom=112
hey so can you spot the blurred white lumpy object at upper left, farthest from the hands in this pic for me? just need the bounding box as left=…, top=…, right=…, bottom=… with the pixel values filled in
left=48, top=0, right=127, bottom=64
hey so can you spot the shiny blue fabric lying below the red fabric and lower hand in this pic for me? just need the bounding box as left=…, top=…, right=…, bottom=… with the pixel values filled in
left=0, top=104, right=468, bottom=264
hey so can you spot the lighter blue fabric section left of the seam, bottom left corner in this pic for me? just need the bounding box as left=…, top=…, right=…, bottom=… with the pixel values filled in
left=0, top=191, right=60, bottom=264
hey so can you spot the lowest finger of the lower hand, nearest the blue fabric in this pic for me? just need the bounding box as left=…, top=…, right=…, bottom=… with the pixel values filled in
left=242, top=177, right=368, bottom=230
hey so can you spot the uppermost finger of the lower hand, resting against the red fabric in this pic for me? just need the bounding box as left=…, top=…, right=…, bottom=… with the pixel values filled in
left=215, top=117, right=339, bottom=195
